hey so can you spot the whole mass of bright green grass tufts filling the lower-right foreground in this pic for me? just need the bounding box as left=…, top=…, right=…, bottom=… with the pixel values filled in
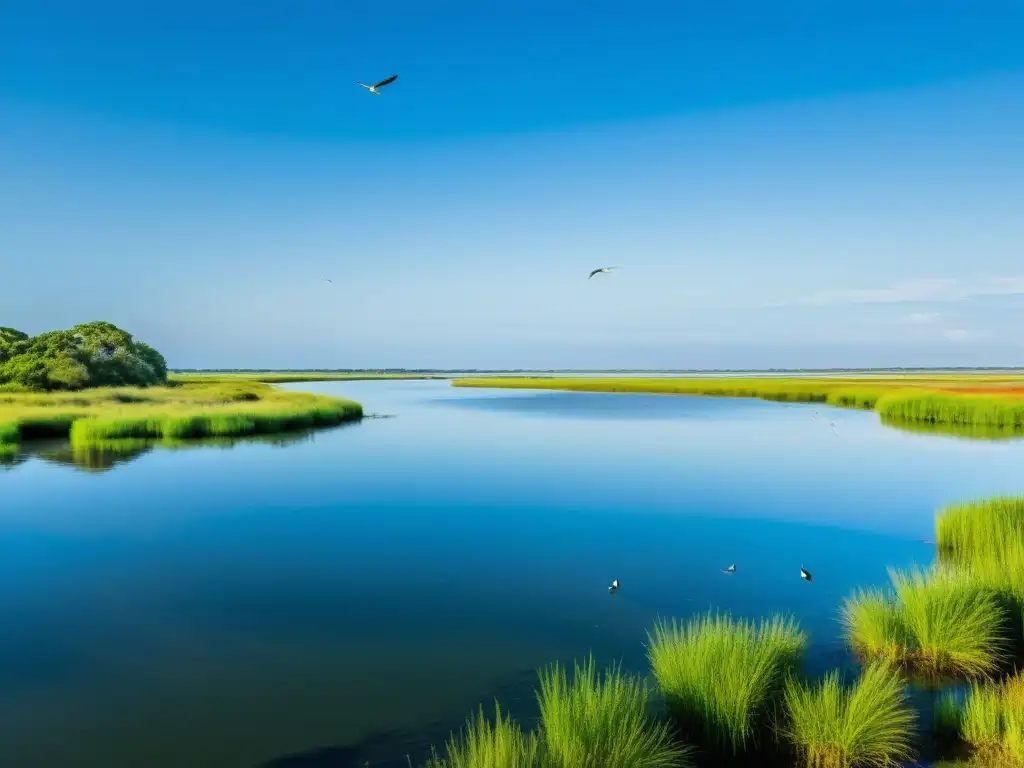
left=423, top=498, right=1024, bottom=768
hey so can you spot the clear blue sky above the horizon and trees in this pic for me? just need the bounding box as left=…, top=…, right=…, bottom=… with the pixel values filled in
left=0, top=0, right=1024, bottom=368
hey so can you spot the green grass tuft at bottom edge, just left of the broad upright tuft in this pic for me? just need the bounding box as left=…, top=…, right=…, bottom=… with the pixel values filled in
left=537, top=656, right=691, bottom=768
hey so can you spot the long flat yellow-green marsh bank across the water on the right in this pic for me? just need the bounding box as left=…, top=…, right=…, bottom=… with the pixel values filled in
left=452, top=374, right=1024, bottom=433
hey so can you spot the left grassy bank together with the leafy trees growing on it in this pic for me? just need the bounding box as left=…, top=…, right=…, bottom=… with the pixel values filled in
left=0, top=323, right=362, bottom=457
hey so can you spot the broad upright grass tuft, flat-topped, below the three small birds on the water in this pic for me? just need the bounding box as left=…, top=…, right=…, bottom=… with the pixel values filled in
left=648, top=613, right=807, bottom=755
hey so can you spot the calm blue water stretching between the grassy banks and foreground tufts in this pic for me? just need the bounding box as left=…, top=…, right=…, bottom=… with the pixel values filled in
left=0, top=381, right=1024, bottom=768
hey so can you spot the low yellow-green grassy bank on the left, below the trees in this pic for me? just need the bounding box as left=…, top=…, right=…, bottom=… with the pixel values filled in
left=0, top=379, right=362, bottom=445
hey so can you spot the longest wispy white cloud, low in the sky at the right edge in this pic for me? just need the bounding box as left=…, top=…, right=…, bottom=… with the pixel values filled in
left=797, top=275, right=1024, bottom=305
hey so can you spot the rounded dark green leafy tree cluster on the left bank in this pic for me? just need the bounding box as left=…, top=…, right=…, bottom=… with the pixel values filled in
left=0, top=323, right=167, bottom=390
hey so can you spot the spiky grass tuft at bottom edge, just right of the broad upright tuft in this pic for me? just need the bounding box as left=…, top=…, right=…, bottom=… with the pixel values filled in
left=781, top=662, right=915, bottom=768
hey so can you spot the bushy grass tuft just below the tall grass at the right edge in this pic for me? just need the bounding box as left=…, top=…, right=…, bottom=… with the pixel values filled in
left=843, top=567, right=1008, bottom=678
